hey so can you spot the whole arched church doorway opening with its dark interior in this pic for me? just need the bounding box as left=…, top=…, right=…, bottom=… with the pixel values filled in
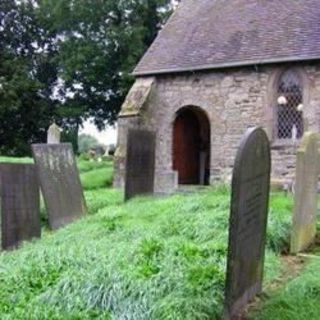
left=173, top=107, right=210, bottom=185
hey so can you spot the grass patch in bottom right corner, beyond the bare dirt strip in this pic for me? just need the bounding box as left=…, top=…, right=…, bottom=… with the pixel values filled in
left=250, top=257, right=320, bottom=320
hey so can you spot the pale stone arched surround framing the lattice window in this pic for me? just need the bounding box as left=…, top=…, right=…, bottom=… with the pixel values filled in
left=266, top=66, right=310, bottom=149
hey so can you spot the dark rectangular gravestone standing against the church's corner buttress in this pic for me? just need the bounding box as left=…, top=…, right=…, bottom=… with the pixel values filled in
left=125, top=130, right=156, bottom=200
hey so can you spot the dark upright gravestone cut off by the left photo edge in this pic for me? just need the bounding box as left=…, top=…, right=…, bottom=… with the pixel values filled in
left=0, top=163, right=41, bottom=250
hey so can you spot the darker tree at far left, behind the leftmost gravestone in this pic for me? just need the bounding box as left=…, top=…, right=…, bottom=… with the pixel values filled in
left=0, top=0, right=56, bottom=155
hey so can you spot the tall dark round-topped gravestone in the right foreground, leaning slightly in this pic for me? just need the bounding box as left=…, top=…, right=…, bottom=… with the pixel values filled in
left=225, top=128, right=271, bottom=319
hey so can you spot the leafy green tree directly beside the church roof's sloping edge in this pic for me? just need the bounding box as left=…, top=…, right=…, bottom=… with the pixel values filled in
left=39, top=0, right=175, bottom=128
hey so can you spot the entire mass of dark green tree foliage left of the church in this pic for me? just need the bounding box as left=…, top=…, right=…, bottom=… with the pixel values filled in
left=0, top=0, right=175, bottom=154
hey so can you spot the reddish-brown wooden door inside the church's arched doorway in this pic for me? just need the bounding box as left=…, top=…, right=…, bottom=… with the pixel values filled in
left=173, top=110, right=200, bottom=184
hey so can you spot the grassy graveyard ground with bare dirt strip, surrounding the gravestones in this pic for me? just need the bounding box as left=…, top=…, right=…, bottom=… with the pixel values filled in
left=0, top=158, right=320, bottom=320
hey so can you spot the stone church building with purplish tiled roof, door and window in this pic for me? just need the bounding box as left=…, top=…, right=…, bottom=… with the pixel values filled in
left=114, top=0, right=320, bottom=192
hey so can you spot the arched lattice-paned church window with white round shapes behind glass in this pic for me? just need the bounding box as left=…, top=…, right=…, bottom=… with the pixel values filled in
left=276, top=70, right=304, bottom=139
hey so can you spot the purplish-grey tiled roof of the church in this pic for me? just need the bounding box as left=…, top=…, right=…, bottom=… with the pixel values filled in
left=134, top=0, right=320, bottom=75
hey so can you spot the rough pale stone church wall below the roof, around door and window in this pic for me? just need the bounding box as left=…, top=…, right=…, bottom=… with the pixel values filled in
left=114, top=63, right=320, bottom=192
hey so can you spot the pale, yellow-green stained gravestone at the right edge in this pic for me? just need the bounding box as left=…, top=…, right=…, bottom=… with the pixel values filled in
left=290, top=132, right=320, bottom=253
